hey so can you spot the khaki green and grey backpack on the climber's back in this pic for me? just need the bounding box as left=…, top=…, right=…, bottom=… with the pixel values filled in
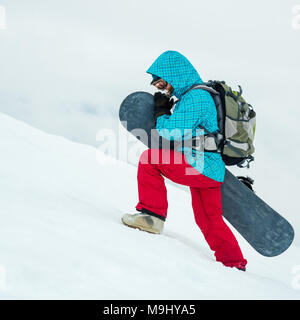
left=185, top=80, right=256, bottom=167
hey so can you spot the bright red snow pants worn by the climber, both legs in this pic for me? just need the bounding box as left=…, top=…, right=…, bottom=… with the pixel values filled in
left=136, top=149, right=247, bottom=268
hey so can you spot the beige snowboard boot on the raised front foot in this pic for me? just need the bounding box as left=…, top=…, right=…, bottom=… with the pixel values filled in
left=122, top=213, right=164, bottom=234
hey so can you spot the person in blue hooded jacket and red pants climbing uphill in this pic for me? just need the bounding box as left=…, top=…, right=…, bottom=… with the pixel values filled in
left=122, top=51, right=247, bottom=270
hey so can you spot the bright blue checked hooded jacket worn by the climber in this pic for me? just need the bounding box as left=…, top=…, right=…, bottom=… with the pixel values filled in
left=147, top=51, right=225, bottom=182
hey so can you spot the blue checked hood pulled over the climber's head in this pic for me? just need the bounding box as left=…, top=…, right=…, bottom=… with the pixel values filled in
left=147, top=51, right=203, bottom=98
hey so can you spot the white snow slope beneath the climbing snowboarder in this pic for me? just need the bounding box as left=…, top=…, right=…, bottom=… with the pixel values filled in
left=0, top=114, right=300, bottom=299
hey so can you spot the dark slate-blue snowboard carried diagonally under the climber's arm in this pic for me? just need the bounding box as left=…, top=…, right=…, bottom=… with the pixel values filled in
left=119, top=91, right=294, bottom=257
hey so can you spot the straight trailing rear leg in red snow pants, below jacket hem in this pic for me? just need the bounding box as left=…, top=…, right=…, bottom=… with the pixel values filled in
left=190, top=184, right=247, bottom=269
